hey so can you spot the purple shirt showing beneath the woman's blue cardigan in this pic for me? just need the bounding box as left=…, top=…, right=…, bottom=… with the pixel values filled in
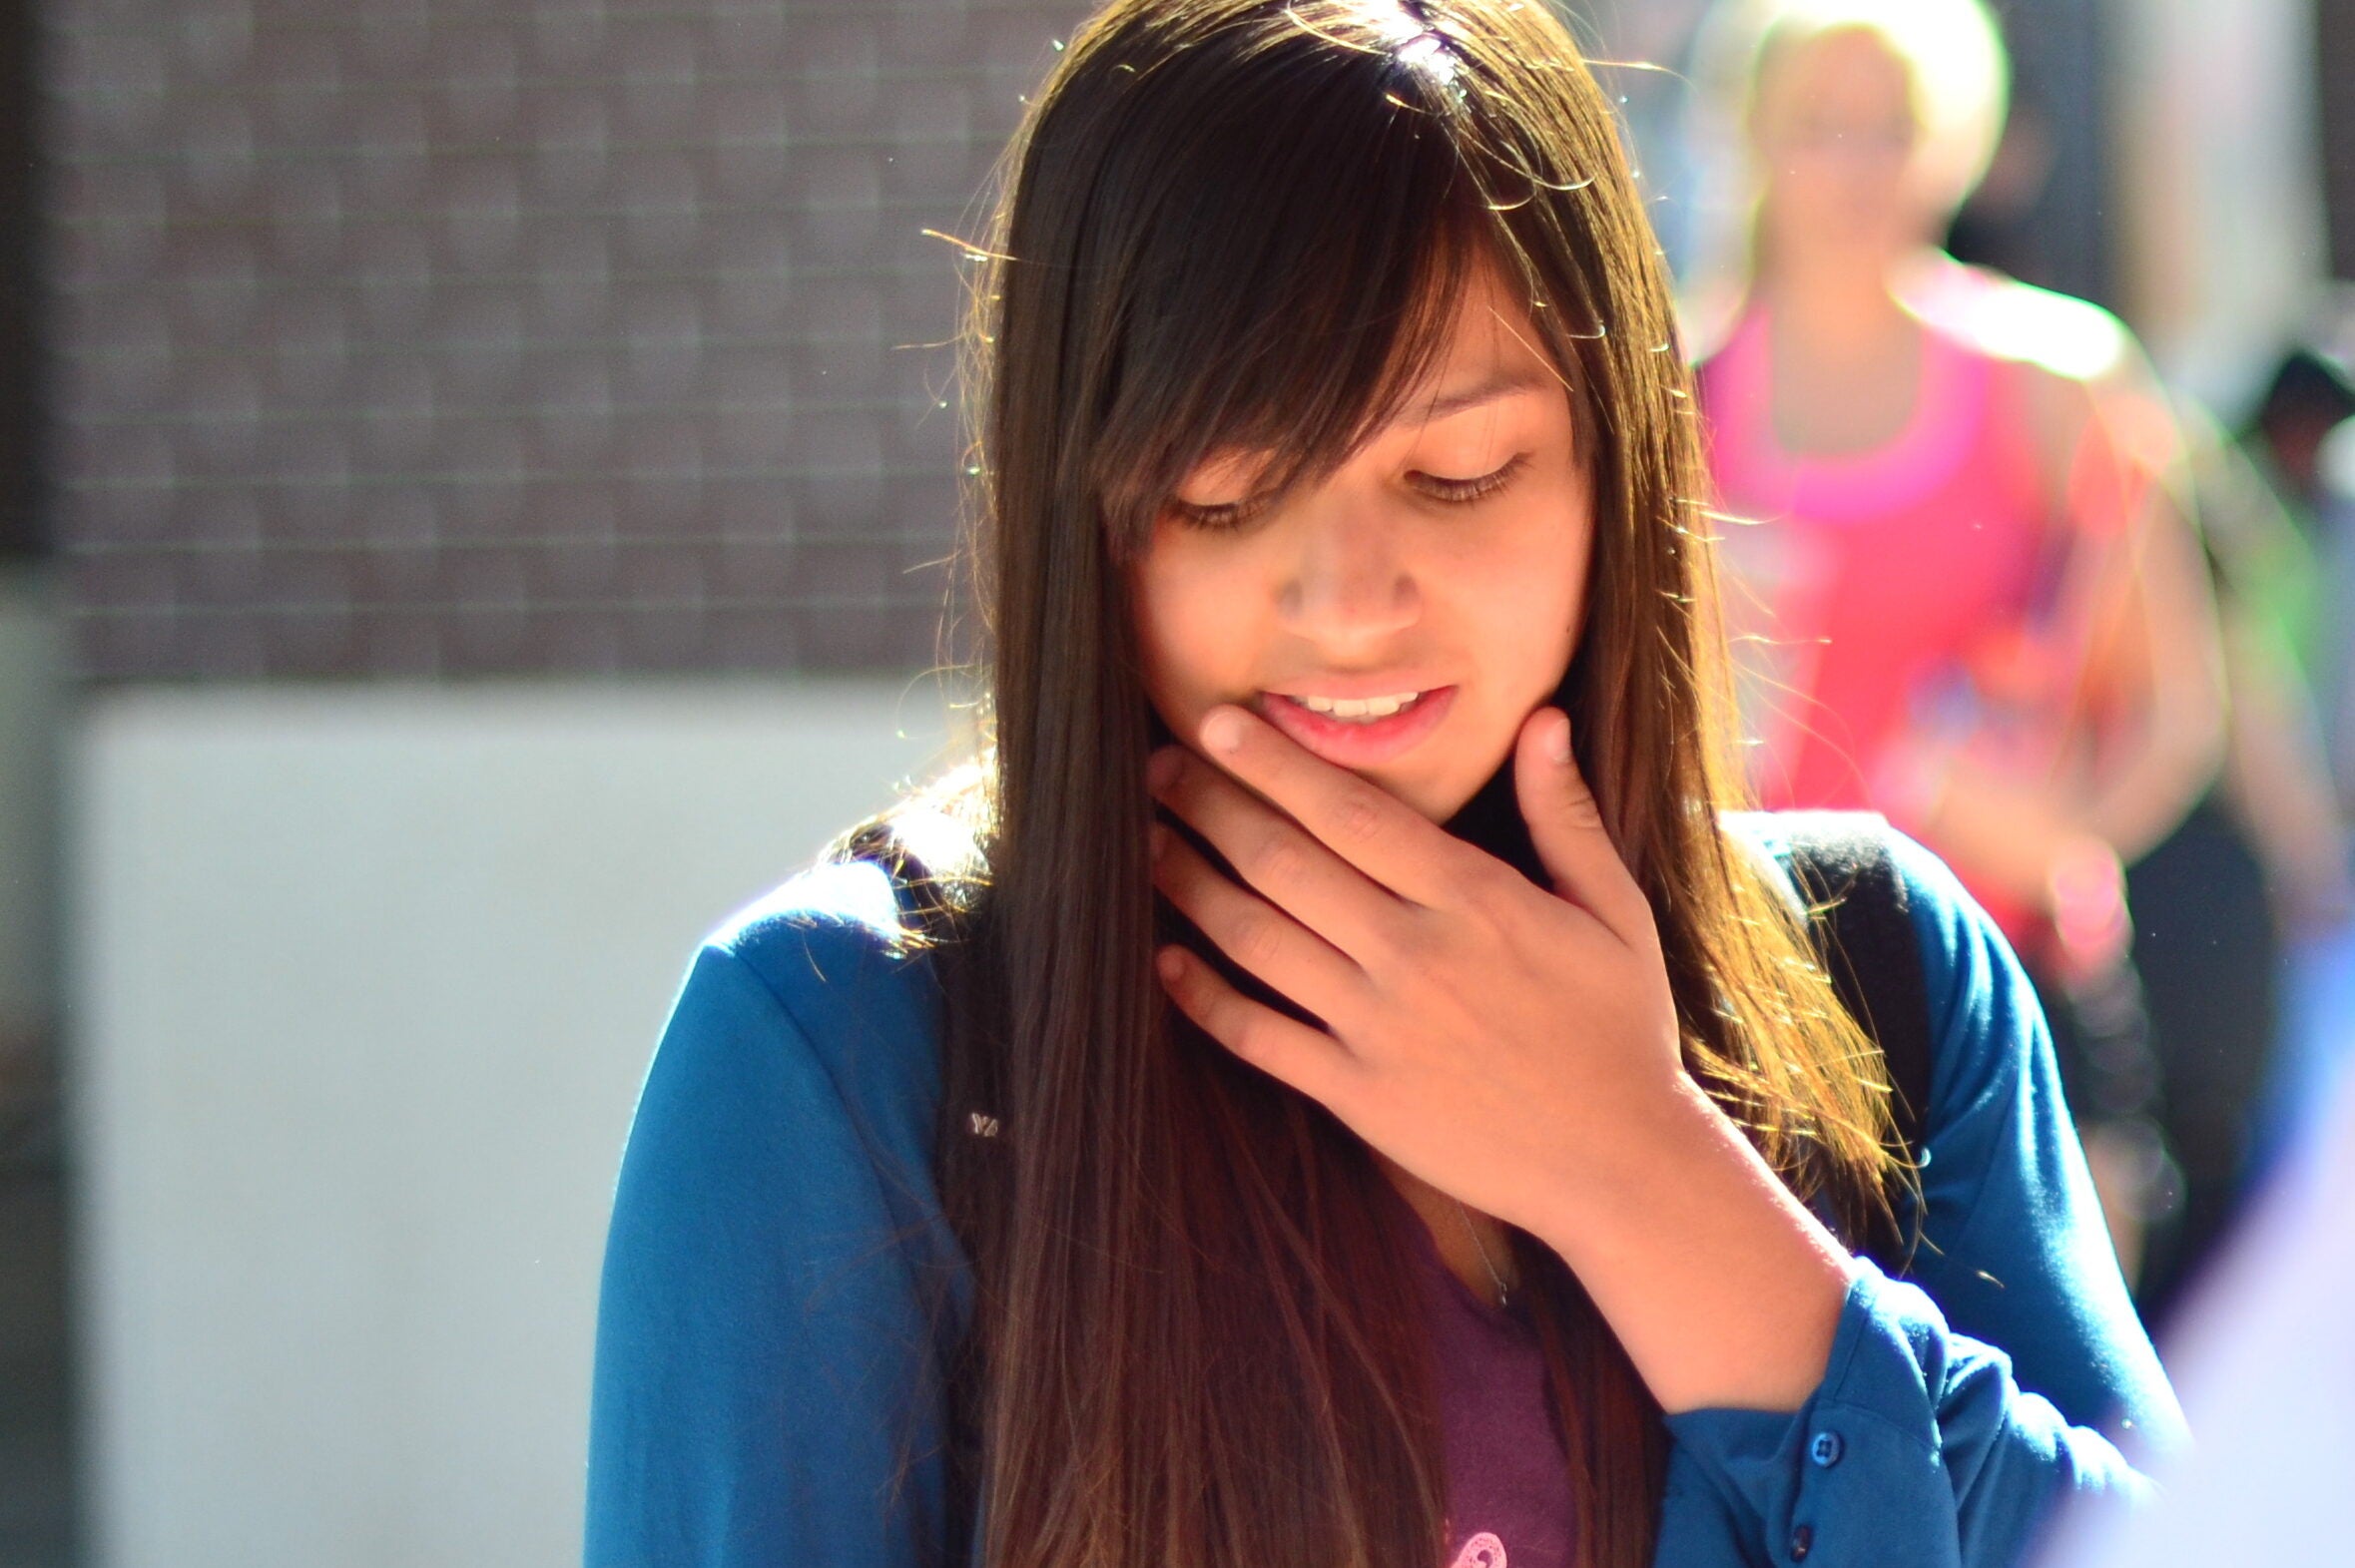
left=1402, top=1199, right=1570, bottom=1568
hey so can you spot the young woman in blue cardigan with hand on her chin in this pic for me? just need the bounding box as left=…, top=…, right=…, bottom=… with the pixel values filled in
left=589, top=0, right=2178, bottom=1568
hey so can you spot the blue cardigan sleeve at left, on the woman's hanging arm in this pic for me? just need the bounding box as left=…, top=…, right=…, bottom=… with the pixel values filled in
left=584, top=942, right=946, bottom=1568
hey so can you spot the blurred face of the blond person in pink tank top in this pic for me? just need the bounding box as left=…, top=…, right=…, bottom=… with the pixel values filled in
left=1750, top=28, right=1946, bottom=257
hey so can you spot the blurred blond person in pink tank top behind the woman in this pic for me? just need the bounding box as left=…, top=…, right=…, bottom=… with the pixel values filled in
left=1698, top=0, right=2223, bottom=1279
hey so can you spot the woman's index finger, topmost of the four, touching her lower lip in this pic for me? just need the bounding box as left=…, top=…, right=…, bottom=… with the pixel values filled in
left=1199, top=704, right=1476, bottom=906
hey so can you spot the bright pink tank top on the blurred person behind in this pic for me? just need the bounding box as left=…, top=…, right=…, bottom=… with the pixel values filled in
left=1700, top=306, right=2061, bottom=944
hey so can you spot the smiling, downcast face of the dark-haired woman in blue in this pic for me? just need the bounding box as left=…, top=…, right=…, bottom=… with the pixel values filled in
left=1130, top=253, right=1592, bottom=821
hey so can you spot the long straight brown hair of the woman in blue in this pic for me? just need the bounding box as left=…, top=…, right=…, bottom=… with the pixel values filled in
left=844, top=0, right=1891, bottom=1568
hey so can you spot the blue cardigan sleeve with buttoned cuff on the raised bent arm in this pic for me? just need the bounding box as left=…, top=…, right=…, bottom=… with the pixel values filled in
left=1655, top=833, right=2183, bottom=1568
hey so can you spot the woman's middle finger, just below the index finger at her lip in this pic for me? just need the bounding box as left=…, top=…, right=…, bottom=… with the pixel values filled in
left=1154, top=747, right=1404, bottom=965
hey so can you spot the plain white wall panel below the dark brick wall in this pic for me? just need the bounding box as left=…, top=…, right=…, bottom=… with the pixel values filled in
left=68, top=681, right=944, bottom=1568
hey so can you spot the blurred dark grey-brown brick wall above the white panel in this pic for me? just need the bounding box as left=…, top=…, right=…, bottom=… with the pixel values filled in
left=42, top=0, right=1085, bottom=681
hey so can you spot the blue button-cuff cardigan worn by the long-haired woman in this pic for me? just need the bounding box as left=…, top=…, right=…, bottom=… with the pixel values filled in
left=586, top=814, right=2183, bottom=1568
